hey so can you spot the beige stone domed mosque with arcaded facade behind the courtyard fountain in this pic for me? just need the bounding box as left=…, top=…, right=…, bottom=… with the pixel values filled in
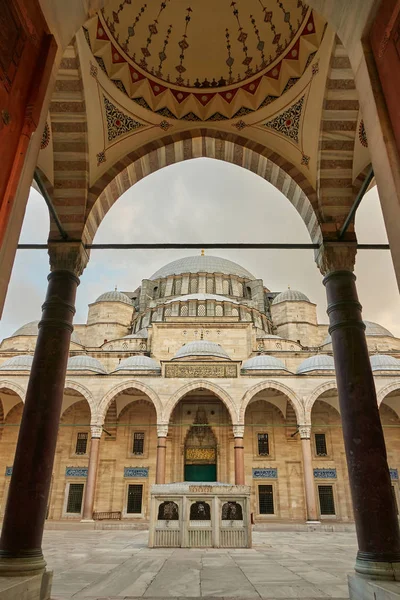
left=0, top=253, right=400, bottom=527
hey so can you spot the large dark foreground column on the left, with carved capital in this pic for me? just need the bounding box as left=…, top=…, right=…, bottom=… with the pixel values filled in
left=0, top=243, right=87, bottom=576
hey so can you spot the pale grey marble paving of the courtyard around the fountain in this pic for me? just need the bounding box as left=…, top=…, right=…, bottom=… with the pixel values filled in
left=44, top=530, right=356, bottom=600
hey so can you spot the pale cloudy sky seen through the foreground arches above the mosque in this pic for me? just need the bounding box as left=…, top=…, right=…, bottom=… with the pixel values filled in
left=0, top=158, right=400, bottom=339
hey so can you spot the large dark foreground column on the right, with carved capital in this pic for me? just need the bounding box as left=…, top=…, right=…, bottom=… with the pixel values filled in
left=317, top=245, right=400, bottom=580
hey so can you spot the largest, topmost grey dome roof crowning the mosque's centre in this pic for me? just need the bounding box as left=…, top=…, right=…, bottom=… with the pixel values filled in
left=150, top=256, right=255, bottom=280
